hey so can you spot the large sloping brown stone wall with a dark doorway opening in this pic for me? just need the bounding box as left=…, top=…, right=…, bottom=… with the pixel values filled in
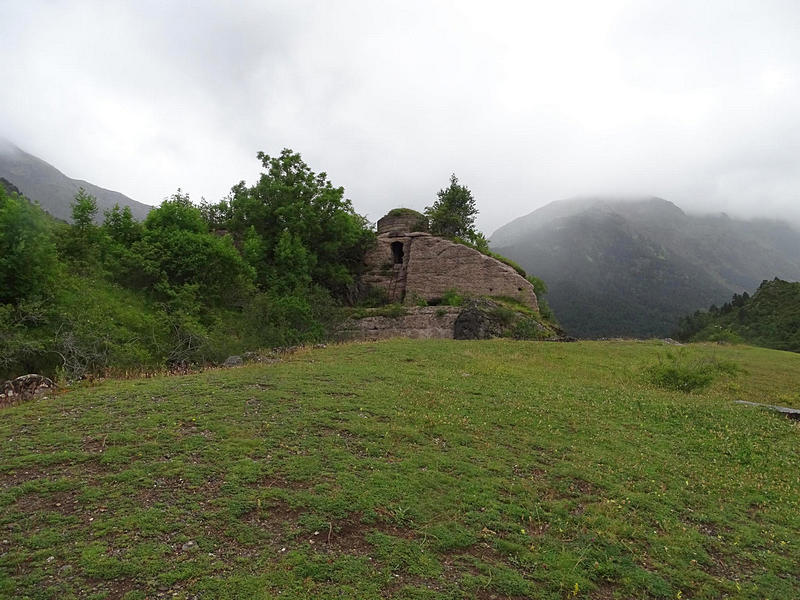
left=364, top=231, right=539, bottom=310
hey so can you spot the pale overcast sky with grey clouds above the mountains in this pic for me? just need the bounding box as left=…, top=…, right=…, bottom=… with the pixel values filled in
left=0, top=0, right=800, bottom=234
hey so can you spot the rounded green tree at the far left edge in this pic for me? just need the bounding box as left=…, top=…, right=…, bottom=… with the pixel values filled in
left=0, top=185, right=58, bottom=304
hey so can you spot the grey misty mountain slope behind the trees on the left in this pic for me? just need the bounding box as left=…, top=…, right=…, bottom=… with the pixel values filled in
left=0, top=139, right=152, bottom=221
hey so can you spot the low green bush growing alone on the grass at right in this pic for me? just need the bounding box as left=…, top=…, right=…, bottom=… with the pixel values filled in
left=646, top=351, right=739, bottom=393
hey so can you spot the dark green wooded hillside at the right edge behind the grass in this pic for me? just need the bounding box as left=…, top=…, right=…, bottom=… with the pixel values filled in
left=675, top=278, right=800, bottom=352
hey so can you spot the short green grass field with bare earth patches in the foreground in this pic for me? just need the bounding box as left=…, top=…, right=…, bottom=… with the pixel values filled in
left=0, top=340, right=800, bottom=600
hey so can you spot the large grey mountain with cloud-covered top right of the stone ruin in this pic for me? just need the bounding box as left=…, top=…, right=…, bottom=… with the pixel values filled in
left=490, top=197, right=800, bottom=337
